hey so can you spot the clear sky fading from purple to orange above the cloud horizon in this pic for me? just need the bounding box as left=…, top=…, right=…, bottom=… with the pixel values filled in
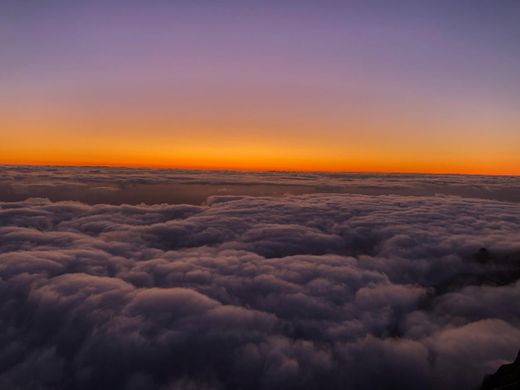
left=0, top=0, right=520, bottom=174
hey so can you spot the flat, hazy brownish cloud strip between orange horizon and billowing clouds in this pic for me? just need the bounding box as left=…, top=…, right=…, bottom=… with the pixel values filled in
left=0, top=166, right=520, bottom=205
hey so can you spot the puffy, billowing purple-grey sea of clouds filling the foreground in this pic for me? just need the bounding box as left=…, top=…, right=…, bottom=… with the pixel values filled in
left=0, top=194, right=520, bottom=389
